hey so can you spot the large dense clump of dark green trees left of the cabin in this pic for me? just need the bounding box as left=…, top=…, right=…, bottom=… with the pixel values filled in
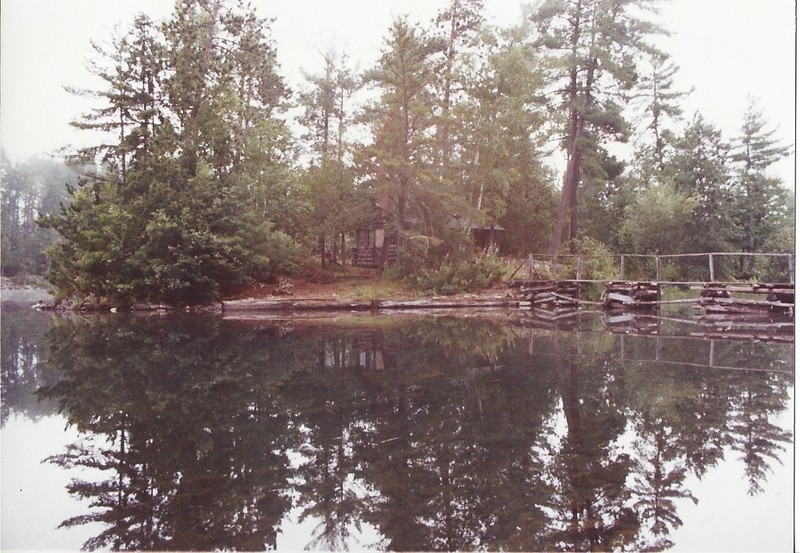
left=46, top=0, right=300, bottom=304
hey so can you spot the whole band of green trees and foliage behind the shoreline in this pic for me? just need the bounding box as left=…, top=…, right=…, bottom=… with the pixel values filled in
left=2, top=0, right=794, bottom=304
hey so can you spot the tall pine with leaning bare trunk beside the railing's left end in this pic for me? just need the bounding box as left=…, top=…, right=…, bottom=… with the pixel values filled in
left=532, top=0, right=659, bottom=256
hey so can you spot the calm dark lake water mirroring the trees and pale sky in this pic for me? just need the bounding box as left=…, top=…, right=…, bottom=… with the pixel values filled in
left=0, top=305, right=794, bottom=551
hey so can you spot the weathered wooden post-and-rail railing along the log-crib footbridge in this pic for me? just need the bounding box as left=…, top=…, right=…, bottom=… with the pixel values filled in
left=511, top=252, right=795, bottom=284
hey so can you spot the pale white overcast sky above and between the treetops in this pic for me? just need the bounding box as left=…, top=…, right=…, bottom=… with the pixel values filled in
left=0, top=0, right=796, bottom=186
